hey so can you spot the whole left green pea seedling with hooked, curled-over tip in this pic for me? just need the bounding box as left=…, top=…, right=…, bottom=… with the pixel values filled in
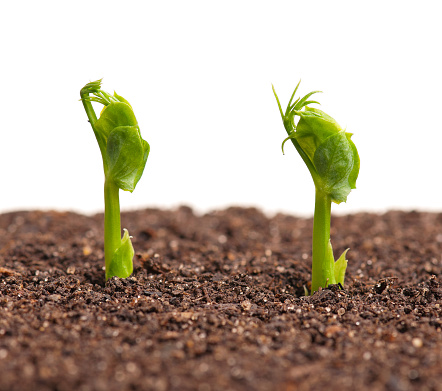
left=80, top=80, right=150, bottom=279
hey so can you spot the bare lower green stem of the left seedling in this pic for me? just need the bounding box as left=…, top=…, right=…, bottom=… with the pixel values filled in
left=104, top=179, right=121, bottom=279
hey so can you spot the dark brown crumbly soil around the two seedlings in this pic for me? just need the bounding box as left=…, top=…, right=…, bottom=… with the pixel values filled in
left=0, top=207, right=442, bottom=391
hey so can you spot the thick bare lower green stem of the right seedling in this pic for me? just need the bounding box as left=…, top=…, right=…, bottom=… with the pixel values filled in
left=312, top=189, right=336, bottom=293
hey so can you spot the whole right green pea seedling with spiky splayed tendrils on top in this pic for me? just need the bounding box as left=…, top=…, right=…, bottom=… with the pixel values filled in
left=272, top=82, right=359, bottom=293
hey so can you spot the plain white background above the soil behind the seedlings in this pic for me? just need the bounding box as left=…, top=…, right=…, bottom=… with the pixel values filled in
left=0, top=0, right=442, bottom=215
